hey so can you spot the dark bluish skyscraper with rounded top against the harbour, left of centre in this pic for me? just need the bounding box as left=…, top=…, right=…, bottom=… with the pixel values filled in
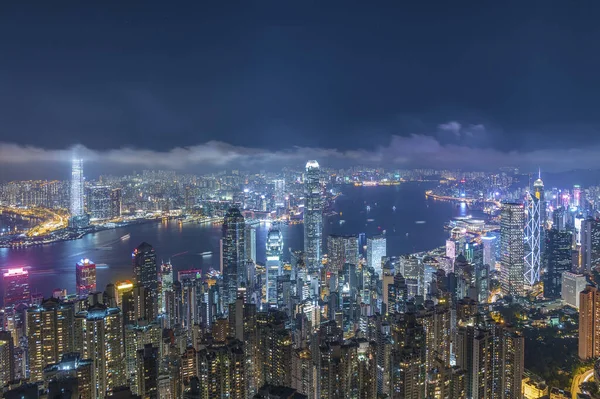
left=222, top=208, right=246, bottom=304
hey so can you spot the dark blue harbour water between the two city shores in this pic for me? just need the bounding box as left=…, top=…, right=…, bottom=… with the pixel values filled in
left=0, top=183, right=454, bottom=296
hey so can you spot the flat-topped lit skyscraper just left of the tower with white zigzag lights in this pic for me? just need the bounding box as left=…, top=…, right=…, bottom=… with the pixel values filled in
left=500, top=203, right=525, bottom=296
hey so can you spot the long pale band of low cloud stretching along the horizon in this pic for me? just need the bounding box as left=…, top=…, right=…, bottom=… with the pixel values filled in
left=0, top=128, right=600, bottom=172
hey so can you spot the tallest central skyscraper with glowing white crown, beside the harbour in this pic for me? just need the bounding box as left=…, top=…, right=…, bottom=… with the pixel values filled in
left=303, top=161, right=323, bottom=270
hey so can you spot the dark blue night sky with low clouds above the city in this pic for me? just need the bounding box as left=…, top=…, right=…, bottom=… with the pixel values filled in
left=0, top=1, right=600, bottom=178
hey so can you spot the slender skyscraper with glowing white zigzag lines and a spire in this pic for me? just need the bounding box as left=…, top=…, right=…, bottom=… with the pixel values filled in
left=524, top=179, right=544, bottom=287
